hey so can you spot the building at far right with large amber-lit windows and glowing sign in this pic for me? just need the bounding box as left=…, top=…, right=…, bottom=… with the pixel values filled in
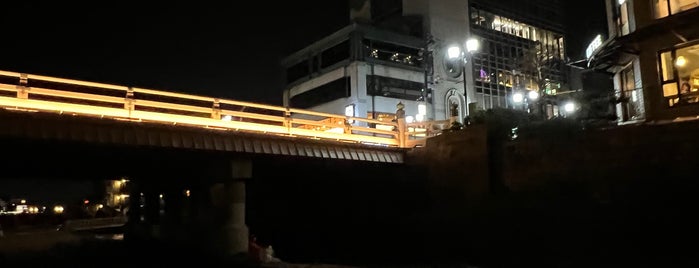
left=588, top=0, right=699, bottom=124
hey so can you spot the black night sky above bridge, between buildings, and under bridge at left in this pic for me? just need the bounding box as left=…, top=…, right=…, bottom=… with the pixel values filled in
left=0, top=0, right=606, bottom=204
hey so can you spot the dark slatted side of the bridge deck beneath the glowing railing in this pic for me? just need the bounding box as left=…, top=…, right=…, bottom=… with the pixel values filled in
left=0, top=108, right=405, bottom=163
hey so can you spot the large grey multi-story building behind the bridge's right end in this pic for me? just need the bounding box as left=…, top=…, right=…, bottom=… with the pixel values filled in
left=283, top=0, right=567, bottom=123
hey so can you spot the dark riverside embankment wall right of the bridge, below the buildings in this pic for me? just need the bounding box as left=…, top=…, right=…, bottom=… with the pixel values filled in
left=411, top=122, right=699, bottom=267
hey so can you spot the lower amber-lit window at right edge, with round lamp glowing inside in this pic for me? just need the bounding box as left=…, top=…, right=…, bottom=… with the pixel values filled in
left=659, top=44, right=699, bottom=107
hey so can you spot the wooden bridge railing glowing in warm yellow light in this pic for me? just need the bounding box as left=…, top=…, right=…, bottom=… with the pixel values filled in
left=0, top=71, right=438, bottom=147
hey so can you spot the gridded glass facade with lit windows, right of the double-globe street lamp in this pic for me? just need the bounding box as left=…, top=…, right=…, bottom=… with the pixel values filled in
left=470, top=7, right=565, bottom=109
